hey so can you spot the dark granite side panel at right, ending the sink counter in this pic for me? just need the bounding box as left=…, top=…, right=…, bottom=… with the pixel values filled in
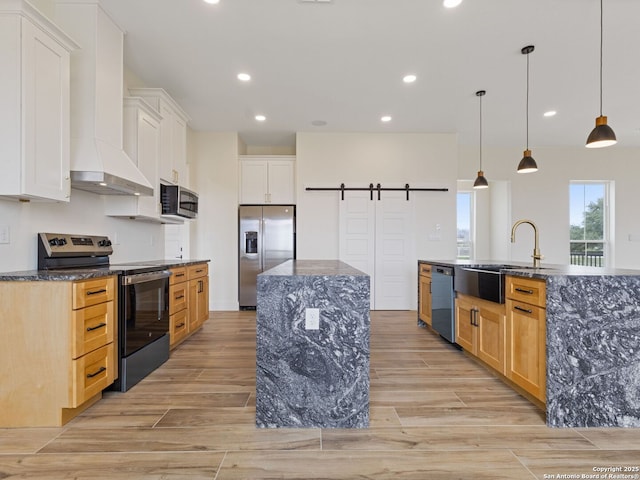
left=547, top=276, right=640, bottom=427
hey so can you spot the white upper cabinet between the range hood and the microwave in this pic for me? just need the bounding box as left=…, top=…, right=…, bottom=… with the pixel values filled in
left=105, top=97, right=162, bottom=222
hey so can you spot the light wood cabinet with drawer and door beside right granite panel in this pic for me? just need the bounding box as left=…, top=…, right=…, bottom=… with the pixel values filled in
left=506, top=276, right=546, bottom=402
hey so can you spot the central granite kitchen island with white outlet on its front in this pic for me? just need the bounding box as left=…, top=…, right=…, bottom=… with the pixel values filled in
left=256, top=260, right=370, bottom=428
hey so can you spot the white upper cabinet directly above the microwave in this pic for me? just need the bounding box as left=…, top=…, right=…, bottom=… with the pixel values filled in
left=129, top=88, right=189, bottom=186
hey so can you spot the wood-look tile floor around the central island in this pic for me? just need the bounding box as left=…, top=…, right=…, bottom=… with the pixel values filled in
left=0, top=311, right=640, bottom=480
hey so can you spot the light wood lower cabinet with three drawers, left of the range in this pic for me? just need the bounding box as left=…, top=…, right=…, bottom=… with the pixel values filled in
left=0, top=276, right=117, bottom=427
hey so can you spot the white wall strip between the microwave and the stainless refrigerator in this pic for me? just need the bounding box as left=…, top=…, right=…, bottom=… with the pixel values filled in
left=189, top=132, right=239, bottom=310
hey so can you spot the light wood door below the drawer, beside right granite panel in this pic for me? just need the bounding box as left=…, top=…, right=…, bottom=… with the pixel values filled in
left=506, top=299, right=546, bottom=401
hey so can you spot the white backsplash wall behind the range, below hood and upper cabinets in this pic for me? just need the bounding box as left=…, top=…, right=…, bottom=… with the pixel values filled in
left=0, top=189, right=164, bottom=272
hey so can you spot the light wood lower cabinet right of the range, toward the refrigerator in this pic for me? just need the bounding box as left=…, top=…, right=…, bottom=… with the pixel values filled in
left=169, top=263, right=209, bottom=349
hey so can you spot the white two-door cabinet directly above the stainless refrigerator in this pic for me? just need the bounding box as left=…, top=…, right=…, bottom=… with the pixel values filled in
left=240, top=155, right=296, bottom=205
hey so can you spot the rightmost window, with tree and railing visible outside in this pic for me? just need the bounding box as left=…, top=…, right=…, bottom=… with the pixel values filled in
left=569, top=182, right=609, bottom=267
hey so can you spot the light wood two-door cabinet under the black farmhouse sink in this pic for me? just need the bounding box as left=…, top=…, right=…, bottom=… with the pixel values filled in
left=456, top=294, right=506, bottom=375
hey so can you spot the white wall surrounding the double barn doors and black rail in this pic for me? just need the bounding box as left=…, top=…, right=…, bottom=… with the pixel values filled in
left=296, top=133, right=457, bottom=303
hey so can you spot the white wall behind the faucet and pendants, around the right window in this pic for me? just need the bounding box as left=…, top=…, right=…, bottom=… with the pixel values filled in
left=458, top=146, right=640, bottom=268
